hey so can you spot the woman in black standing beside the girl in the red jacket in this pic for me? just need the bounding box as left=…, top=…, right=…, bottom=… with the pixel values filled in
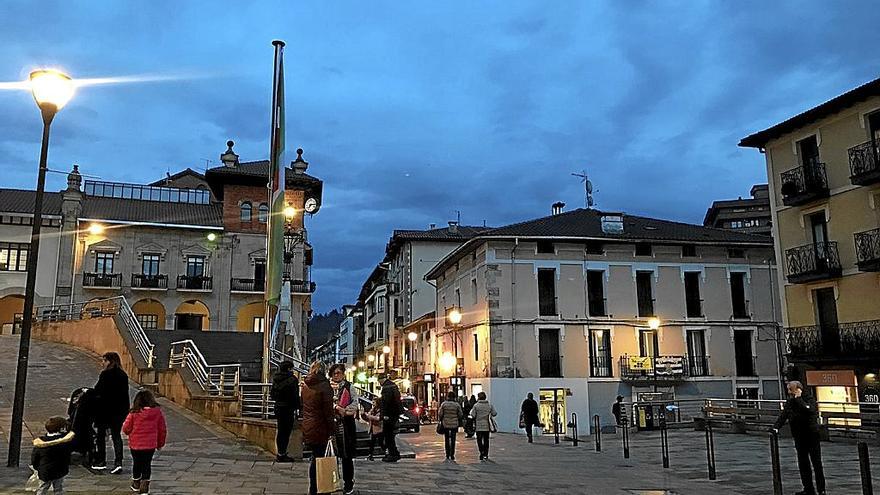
left=92, top=352, right=128, bottom=474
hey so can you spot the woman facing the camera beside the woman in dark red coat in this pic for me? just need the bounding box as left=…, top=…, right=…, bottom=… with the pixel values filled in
left=330, top=363, right=360, bottom=495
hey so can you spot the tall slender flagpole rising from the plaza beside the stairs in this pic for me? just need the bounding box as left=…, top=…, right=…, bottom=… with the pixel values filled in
left=262, top=40, right=284, bottom=383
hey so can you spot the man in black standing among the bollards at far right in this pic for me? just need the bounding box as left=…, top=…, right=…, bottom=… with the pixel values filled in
left=773, top=381, right=825, bottom=495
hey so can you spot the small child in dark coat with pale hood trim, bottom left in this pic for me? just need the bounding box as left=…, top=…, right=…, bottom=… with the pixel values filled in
left=31, top=416, right=74, bottom=495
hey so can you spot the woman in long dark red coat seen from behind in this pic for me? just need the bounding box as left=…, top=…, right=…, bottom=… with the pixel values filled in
left=300, top=361, right=336, bottom=495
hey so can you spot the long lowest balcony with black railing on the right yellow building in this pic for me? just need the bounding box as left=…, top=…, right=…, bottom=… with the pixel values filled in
left=785, top=320, right=880, bottom=361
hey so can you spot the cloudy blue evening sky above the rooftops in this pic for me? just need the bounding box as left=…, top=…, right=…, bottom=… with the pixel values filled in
left=0, top=0, right=880, bottom=311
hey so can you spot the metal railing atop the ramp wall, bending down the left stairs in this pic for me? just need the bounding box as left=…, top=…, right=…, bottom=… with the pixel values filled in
left=34, top=296, right=155, bottom=368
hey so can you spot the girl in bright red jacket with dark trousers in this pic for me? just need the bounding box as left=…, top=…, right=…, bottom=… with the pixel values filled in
left=122, top=390, right=167, bottom=494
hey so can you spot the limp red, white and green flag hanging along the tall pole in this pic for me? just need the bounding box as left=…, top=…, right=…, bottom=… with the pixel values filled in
left=266, top=40, right=285, bottom=306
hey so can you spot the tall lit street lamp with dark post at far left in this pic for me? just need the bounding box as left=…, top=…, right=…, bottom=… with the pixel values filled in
left=6, top=69, right=75, bottom=467
